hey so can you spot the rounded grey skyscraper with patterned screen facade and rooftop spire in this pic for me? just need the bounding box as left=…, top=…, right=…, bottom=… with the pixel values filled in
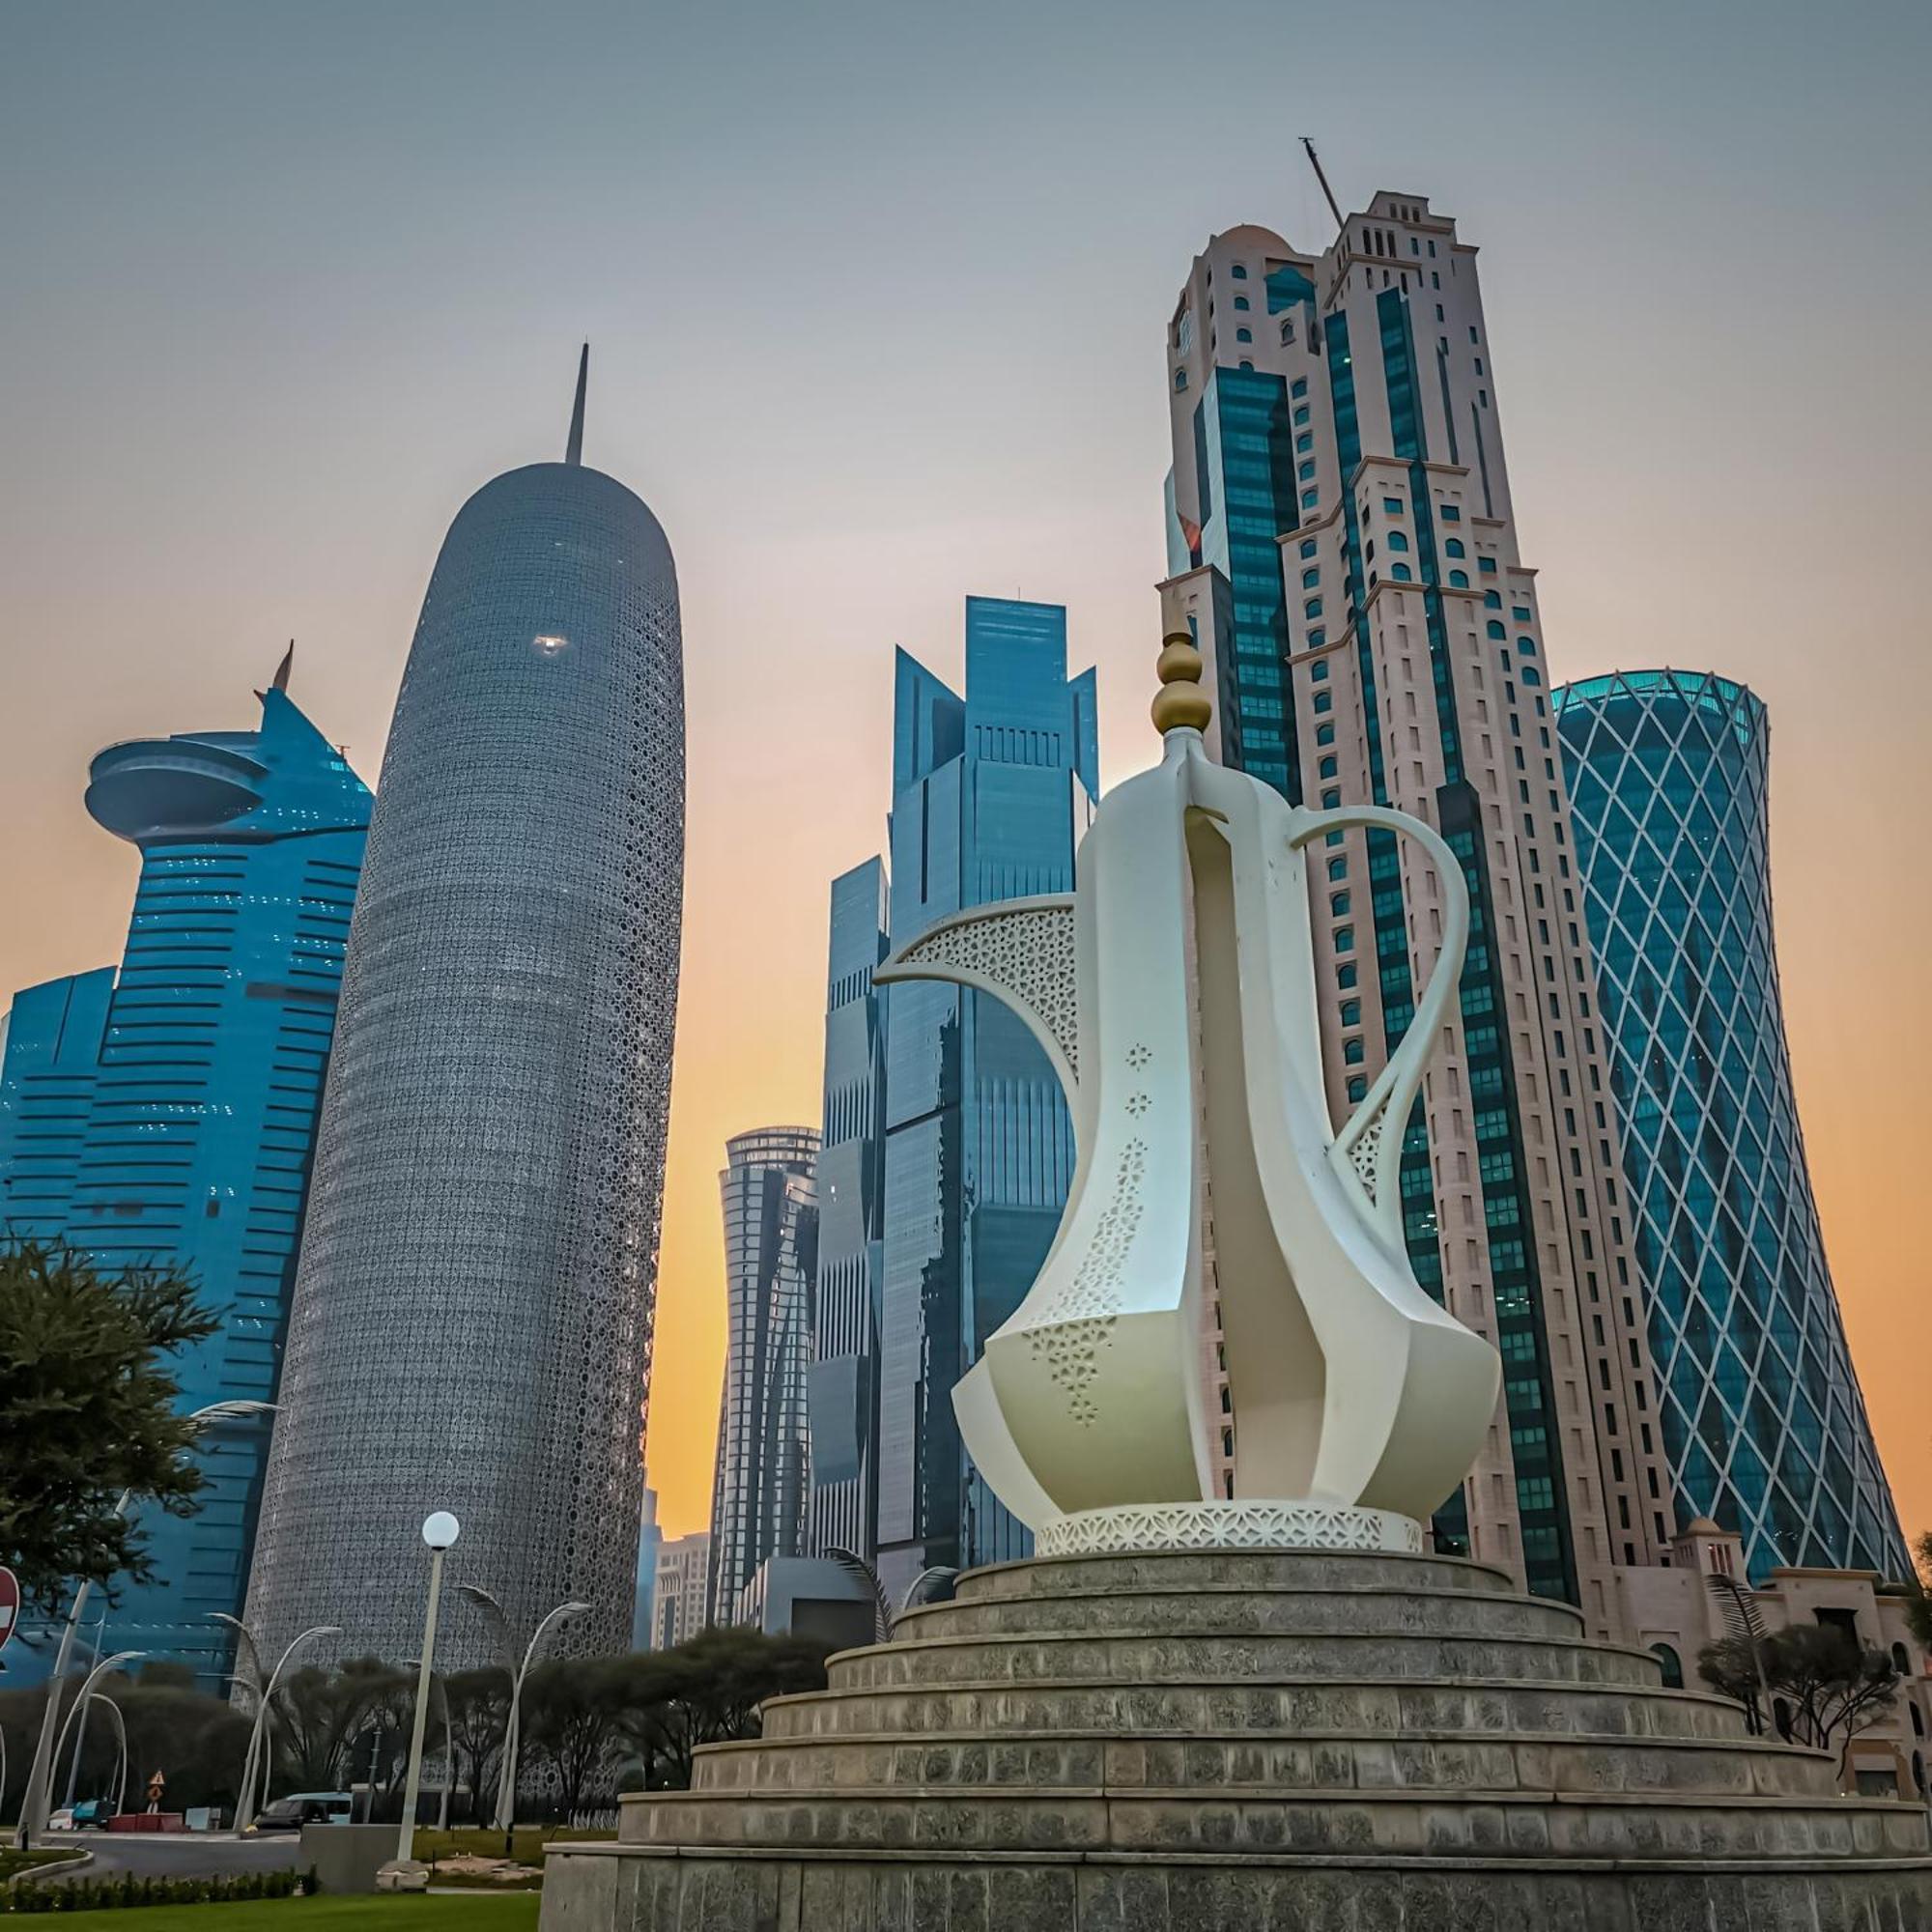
left=247, top=352, right=684, bottom=1667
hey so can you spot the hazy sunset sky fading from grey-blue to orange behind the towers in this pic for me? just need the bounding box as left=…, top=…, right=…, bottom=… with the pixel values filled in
left=0, top=0, right=1932, bottom=1534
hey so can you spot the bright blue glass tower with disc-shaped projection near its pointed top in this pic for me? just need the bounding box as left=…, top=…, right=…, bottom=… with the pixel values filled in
left=0, top=661, right=371, bottom=1689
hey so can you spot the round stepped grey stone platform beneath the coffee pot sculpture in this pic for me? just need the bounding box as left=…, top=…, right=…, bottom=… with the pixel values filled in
left=543, top=1549, right=1932, bottom=1932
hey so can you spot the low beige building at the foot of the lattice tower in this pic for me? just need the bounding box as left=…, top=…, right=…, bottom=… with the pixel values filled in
left=1617, top=1517, right=1932, bottom=1801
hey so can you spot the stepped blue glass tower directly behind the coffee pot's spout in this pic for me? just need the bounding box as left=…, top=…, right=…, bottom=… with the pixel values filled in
left=877, top=597, right=1099, bottom=1588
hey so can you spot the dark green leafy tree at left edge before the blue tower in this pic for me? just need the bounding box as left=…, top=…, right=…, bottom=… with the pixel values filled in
left=0, top=1240, right=216, bottom=1611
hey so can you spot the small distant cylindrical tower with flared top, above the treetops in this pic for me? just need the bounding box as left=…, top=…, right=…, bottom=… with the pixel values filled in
left=705, top=1126, right=819, bottom=1623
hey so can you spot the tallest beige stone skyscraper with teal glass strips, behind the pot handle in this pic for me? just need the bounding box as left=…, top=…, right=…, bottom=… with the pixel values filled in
left=1161, top=208, right=1671, bottom=1634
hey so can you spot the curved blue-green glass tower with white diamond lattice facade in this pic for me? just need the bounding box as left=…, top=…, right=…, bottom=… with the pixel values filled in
left=1555, top=670, right=1911, bottom=1582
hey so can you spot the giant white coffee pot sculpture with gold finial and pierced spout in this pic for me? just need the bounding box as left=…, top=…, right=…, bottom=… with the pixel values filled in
left=875, top=634, right=1501, bottom=1551
